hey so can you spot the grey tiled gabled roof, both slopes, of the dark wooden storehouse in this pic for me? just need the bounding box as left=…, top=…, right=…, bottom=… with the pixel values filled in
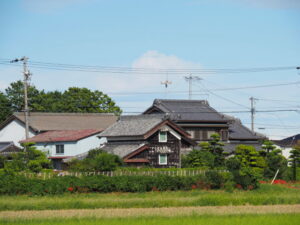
left=99, top=114, right=190, bottom=138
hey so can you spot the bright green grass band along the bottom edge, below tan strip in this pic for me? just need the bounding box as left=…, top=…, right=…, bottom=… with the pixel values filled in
left=0, top=214, right=300, bottom=225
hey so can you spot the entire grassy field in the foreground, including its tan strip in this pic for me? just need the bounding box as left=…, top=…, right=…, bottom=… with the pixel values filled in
left=0, top=184, right=300, bottom=225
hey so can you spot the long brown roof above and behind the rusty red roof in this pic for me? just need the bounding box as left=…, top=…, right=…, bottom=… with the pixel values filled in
left=4, top=112, right=118, bottom=131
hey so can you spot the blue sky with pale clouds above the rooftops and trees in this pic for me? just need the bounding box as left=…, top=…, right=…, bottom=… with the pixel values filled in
left=0, top=0, right=300, bottom=138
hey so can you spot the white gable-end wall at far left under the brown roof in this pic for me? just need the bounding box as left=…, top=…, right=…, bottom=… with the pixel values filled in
left=0, top=120, right=35, bottom=146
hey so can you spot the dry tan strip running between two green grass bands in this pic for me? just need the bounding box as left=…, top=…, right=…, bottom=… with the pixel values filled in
left=0, top=205, right=300, bottom=220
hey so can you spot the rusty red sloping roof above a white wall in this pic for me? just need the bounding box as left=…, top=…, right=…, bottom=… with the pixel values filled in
left=20, top=129, right=101, bottom=143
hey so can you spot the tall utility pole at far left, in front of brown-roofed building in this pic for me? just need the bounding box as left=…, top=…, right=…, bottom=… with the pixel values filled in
left=10, top=56, right=31, bottom=139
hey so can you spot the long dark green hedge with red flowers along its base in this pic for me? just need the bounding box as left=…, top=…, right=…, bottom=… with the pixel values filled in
left=0, top=171, right=230, bottom=195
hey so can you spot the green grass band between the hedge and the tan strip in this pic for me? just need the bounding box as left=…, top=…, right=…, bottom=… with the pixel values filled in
left=0, top=184, right=300, bottom=211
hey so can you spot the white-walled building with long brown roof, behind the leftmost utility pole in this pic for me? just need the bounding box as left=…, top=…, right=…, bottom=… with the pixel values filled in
left=0, top=112, right=118, bottom=147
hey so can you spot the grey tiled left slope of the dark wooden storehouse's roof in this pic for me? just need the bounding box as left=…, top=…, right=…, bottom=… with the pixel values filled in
left=99, top=114, right=166, bottom=137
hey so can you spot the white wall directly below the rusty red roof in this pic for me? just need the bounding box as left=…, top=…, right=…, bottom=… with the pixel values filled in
left=35, top=134, right=106, bottom=157
